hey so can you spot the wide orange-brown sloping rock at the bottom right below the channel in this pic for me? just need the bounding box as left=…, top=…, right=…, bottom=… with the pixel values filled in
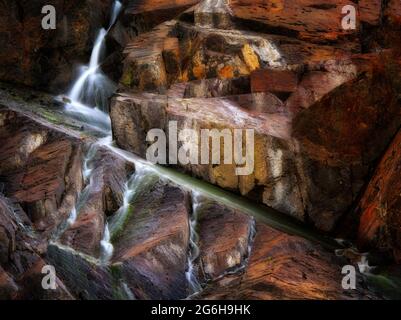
left=198, top=224, right=377, bottom=300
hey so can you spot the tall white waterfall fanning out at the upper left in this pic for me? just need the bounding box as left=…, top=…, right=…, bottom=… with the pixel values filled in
left=62, top=1, right=122, bottom=133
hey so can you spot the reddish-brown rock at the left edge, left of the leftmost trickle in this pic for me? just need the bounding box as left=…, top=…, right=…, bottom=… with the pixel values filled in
left=1, top=110, right=82, bottom=234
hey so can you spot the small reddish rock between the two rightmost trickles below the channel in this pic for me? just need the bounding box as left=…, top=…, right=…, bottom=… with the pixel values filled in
left=196, top=200, right=254, bottom=281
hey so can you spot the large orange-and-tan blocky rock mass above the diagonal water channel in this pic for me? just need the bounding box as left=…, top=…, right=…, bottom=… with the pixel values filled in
left=111, top=1, right=401, bottom=231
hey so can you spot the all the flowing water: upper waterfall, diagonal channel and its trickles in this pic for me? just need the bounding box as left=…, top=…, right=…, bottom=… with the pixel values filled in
left=51, top=1, right=400, bottom=299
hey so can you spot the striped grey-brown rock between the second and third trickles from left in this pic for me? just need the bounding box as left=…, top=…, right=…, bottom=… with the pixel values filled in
left=112, top=181, right=189, bottom=299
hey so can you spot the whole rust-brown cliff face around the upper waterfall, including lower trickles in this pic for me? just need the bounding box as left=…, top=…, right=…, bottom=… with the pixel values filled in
left=0, top=0, right=401, bottom=299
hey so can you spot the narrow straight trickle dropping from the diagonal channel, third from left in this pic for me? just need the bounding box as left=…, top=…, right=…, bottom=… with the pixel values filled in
left=185, top=192, right=202, bottom=295
